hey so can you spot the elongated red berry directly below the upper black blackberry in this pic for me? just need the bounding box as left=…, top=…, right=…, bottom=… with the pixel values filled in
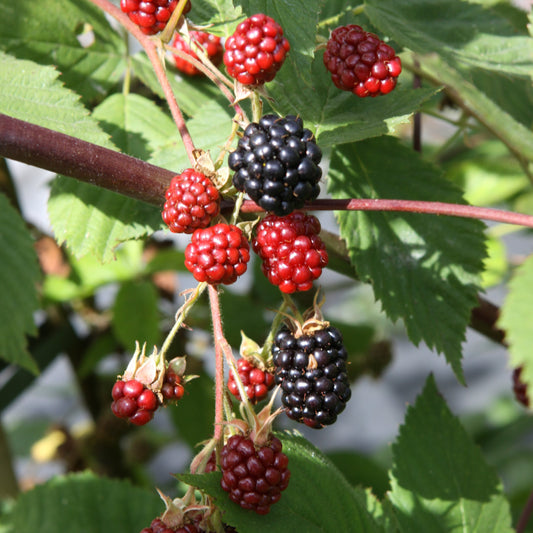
left=252, top=211, right=328, bottom=294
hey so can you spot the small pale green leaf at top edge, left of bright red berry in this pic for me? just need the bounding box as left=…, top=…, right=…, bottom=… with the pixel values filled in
left=189, top=0, right=245, bottom=37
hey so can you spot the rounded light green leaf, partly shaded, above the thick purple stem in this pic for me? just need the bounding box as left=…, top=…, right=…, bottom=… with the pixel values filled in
left=93, top=93, right=175, bottom=160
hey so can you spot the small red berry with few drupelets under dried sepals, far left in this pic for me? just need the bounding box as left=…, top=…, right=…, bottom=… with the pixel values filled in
left=111, top=379, right=159, bottom=426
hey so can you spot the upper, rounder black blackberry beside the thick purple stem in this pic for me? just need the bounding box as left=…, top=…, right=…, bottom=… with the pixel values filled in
left=228, top=115, right=322, bottom=216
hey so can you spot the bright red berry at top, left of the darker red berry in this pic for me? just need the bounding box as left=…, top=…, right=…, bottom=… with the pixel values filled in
left=224, top=13, right=290, bottom=86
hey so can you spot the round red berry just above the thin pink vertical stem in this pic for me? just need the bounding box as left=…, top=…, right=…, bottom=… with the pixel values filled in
left=185, top=224, right=250, bottom=285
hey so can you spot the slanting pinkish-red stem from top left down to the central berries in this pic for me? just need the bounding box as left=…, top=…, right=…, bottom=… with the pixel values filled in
left=91, top=0, right=196, bottom=166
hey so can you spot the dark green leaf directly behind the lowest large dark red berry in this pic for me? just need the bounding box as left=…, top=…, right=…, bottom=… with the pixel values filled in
left=178, top=434, right=385, bottom=533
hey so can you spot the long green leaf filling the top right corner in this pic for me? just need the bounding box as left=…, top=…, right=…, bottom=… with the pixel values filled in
left=365, top=0, right=533, bottom=77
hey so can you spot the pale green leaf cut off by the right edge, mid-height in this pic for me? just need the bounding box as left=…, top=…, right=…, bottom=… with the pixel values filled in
left=498, top=255, right=533, bottom=391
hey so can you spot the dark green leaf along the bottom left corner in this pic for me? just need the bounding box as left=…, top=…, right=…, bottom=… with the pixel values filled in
left=5, top=472, right=164, bottom=533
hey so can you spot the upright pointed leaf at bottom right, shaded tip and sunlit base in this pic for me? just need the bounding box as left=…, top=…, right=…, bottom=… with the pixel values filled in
left=390, top=376, right=513, bottom=533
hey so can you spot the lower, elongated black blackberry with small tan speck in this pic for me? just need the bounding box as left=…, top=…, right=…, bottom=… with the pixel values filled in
left=272, top=326, right=351, bottom=429
